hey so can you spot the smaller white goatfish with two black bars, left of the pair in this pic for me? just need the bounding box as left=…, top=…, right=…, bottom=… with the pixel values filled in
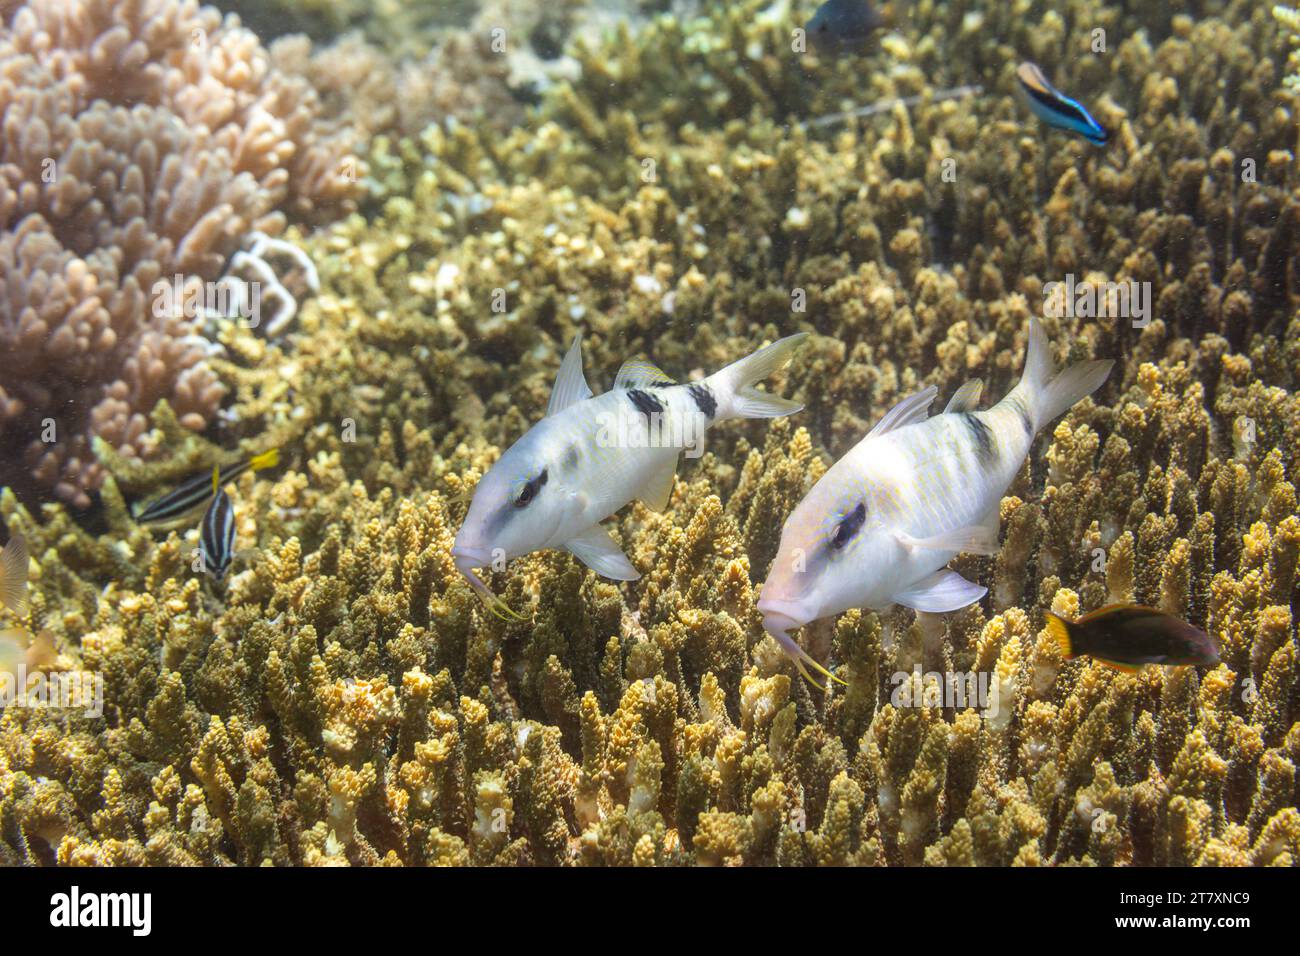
left=451, top=333, right=807, bottom=617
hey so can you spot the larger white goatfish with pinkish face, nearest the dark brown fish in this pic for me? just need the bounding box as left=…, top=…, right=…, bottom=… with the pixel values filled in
left=758, top=319, right=1114, bottom=682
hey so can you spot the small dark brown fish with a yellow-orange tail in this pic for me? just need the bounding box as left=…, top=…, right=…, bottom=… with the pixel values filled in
left=1048, top=604, right=1219, bottom=674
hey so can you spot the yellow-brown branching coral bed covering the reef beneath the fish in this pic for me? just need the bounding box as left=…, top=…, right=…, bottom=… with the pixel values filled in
left=0, top=3, right=1300, bottom=865
